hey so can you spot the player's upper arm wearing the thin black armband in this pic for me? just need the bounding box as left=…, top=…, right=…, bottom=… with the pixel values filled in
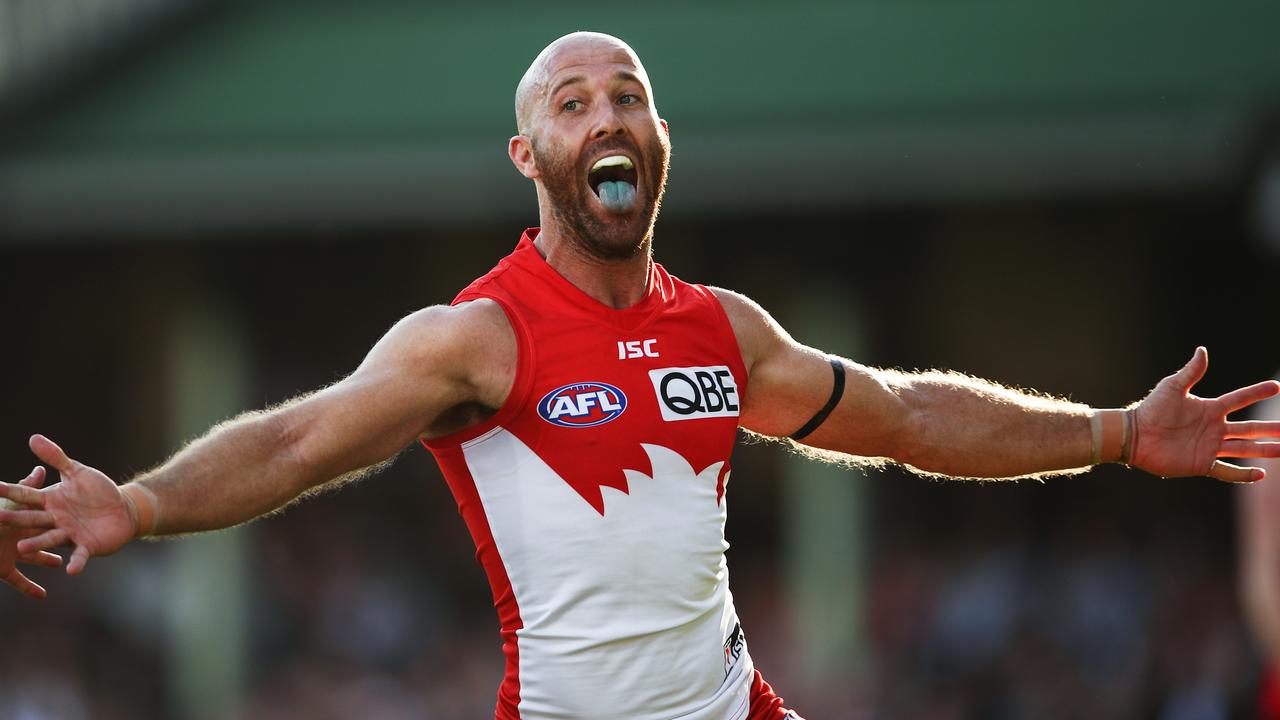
left=716, top=288, right=909, bottom=457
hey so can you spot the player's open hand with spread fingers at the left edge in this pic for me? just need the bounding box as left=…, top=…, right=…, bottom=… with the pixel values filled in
left=0, top=436, right=137, bottom=575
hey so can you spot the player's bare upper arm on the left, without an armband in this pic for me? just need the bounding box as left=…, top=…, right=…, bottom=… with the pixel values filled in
left=275, top=302, right=516, bottom=482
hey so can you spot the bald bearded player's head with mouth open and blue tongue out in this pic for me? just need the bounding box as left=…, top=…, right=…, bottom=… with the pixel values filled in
left=513, top=38, right=671, bottom=259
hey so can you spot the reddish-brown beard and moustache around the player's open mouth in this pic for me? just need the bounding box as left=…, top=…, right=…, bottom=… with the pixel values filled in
left=532, top=128, right=671, bottom=260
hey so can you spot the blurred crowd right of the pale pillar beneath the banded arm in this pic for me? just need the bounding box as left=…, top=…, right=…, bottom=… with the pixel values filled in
left=867, top=515, right=1251, bottom=720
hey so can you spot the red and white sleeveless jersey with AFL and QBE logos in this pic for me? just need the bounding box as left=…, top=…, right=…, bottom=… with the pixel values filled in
left=425, top=229, right=755, bottom=720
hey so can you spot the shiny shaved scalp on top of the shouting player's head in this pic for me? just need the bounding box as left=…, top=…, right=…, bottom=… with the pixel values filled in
left=516, top=32, right=653, bottom=135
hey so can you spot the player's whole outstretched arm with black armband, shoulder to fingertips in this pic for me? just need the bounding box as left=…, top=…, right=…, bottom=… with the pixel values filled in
left=716, top=290, right=1280, bottom=482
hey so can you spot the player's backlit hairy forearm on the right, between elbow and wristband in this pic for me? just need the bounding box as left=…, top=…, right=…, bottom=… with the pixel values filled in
left=882, top=372, right=1094, bottom=478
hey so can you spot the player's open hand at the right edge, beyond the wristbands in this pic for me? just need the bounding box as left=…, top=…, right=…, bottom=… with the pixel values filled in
left=1129, top=347, right=1280, bottom=483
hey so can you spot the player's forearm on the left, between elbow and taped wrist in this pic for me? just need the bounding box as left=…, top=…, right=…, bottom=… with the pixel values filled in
left=133, top=411, right=324, bottom=534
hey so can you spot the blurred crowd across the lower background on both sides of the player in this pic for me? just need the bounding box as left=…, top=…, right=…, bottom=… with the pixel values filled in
left=0, top=448, right=1256, bottom=720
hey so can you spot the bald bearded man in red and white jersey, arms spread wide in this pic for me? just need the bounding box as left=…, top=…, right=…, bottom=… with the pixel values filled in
left=0, top=33, right=1280, bottom=720
